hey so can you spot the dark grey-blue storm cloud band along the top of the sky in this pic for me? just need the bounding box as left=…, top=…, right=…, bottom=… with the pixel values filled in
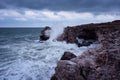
left=0, top=0, right=120, bottom=12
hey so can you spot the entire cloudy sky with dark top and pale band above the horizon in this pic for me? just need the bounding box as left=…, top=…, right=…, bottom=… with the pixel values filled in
left=0, top=0, right=120, bottom=27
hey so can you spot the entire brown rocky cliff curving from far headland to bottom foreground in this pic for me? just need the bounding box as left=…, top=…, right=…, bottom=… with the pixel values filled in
left=51, top=20, right=120, bottom=80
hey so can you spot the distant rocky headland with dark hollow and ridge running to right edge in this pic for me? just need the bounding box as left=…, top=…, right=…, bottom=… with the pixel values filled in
left=57, top=20, right=120, bottom=46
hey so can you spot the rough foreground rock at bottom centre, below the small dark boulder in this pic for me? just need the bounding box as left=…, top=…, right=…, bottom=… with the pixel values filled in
left=51, top=60, right=86, bottom=80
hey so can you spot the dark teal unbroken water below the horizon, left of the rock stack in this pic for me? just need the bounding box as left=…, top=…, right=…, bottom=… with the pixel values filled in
left=0, top=28, right=41, bottom=44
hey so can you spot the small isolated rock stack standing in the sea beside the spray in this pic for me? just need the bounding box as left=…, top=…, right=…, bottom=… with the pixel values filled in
left=40, top=26, right=51, bottom=41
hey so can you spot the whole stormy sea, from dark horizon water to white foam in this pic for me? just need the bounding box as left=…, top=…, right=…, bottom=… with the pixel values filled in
left=0, top=28, right=95, bottom=80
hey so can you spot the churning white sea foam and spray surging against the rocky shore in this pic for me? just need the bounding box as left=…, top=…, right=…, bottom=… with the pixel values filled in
left=0, top=28, right=95, bottom=80
